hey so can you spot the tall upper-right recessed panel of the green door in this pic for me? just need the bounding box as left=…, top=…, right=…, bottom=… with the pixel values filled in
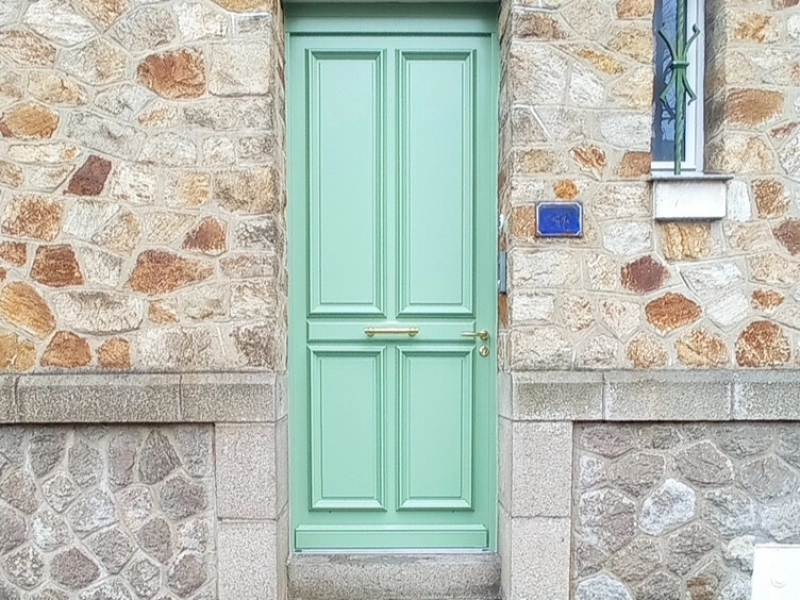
left=398, top=52, right=475, bottom=316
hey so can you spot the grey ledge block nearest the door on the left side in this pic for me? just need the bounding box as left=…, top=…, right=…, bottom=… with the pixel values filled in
left=181, top=373, right=276, bottom=422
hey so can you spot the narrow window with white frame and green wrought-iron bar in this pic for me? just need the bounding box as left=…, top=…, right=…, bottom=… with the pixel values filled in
left=652, top=0, right=704, bottom=174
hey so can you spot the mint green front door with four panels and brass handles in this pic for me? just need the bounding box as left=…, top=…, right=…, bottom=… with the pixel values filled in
left=287, top=4, right=497, bottom=550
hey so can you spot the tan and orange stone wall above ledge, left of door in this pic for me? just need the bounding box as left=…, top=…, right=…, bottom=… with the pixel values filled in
left=0, top=0, right=286, bottom=372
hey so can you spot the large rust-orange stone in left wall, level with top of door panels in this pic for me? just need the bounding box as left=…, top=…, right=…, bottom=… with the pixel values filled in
left=136, top=48, right=206, bottom=98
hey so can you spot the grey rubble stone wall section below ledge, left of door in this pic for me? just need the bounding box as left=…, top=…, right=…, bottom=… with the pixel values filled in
left=0, top=426, right=217, bottom=600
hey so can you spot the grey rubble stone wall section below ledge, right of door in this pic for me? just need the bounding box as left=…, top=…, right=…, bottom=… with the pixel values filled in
left=572, top=423, right=800, bottom=600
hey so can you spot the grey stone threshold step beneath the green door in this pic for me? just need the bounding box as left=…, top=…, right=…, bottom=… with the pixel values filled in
left=288, top=552, right=500, bottom=600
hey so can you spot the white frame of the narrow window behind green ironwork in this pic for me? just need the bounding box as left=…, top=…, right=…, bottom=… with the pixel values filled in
left=650, top=0, right=705, bottom=175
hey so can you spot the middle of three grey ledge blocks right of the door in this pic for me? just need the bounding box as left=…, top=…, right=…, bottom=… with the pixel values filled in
left=604, top=371, right=731, bottom=421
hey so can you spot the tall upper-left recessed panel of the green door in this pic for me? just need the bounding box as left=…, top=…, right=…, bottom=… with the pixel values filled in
left=307, top=51, right=385, bottom=315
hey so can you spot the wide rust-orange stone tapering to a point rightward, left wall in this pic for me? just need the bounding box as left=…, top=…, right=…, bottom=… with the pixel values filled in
left=128, top=250, right=214, bottom=295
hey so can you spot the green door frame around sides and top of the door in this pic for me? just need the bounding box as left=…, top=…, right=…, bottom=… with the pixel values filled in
left=284, top=2, right=500, bottom=553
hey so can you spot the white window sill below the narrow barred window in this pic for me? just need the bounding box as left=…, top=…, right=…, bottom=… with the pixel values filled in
left=650, top=171, right=732, bottom=221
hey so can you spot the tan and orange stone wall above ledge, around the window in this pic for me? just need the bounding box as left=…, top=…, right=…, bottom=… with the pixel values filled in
left=500, top=0, right=800, bottom=372
